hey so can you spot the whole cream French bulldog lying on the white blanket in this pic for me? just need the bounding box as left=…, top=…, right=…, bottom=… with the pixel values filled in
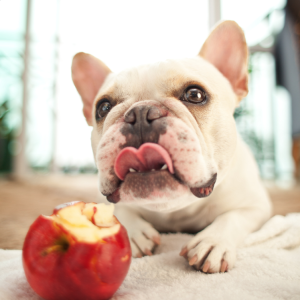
left=72, top=21, right=272, bottom=273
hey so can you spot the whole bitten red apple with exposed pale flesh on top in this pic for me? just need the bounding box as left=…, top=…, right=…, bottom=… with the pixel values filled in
left=23, top=202, right=131, bottom=300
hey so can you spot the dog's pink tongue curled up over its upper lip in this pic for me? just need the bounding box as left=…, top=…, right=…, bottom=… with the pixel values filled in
left=115, top=143, right=174, bottom=180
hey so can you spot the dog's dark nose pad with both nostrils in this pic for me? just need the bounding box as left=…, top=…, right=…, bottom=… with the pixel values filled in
left=125, top=105, right=165, bottom=125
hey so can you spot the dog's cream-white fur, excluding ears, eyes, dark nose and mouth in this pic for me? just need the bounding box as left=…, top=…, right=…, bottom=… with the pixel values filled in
left=72, top=23, right=271, bottom=272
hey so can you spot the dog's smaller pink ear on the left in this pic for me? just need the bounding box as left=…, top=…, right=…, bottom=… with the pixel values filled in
left=72, top=52, right=111, bottom=125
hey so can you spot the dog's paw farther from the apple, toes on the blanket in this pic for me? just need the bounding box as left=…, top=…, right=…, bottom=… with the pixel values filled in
left=180, top=232, right=236, bottom=273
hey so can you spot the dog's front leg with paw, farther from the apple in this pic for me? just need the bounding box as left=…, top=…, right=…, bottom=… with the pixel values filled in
left=180, top=208, right=266, bottom=273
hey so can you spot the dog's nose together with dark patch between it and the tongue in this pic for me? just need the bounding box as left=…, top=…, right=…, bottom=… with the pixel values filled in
left=121, top=105, right=167, bottom=148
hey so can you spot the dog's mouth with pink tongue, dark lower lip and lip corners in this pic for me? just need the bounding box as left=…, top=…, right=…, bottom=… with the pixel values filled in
left=107, top=143, right=217, bottom=203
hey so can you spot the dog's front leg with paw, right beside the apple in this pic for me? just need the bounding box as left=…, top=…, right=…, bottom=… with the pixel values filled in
left=115, top=203, right=160, bottom=257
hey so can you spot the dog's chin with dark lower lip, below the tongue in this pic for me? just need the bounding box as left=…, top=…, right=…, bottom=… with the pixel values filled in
left=107, top=170, right=216, bottom=211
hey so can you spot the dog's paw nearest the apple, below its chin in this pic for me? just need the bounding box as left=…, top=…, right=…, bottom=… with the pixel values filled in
left=127, top=220, right=160, bottom=257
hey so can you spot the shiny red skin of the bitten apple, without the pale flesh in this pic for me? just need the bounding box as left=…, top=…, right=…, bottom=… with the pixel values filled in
left=23, top=216, right=131, bottom=300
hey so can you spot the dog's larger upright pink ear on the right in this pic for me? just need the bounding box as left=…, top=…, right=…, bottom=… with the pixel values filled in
left=199, top=21, right=248, bottom=100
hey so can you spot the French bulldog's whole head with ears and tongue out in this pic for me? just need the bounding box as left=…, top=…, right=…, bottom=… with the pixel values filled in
left=72, top=21, right=248, bottom=210
